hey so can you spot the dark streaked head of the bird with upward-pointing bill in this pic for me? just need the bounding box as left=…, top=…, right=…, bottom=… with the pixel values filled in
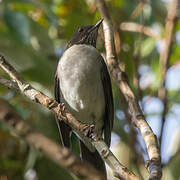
left=67, top=19, right=103, bottom=49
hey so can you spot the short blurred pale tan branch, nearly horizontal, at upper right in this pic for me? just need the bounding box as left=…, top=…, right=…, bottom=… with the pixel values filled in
left=120, top=22, right=161, bottom=40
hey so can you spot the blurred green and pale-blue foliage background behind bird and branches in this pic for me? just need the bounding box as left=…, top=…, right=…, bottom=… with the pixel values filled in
left=0, top=0, right=180, bottom=180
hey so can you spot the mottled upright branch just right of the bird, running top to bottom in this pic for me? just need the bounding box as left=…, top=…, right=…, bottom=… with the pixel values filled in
left=96, top=0, right=162, bottom=180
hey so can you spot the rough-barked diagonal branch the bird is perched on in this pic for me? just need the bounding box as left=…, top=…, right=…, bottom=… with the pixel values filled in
left=0, top=55, right=138, bottom=180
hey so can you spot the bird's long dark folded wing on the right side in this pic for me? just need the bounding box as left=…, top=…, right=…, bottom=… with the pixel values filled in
left=100, top=56, right=114, bottom=146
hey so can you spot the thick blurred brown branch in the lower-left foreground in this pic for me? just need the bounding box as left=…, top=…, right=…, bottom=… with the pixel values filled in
left=0, top=99, right=105, bottom=180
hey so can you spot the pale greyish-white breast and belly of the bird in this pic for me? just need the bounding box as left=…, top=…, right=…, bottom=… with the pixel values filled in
left=57, top=45, right=105, bottom=133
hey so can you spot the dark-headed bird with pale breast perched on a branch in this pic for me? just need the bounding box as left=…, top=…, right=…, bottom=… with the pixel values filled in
left=54, top=19, right=114, bottom=174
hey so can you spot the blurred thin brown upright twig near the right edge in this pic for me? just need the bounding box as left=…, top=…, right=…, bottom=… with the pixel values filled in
left=158, top=0, right=178, bottom=150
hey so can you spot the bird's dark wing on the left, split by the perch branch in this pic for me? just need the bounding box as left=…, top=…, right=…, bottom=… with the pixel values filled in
left=54, top=73, right=71, bottom=147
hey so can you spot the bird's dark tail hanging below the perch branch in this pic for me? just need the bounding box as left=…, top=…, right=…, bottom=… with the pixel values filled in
left=80, top=141, right=107, bottom=176
